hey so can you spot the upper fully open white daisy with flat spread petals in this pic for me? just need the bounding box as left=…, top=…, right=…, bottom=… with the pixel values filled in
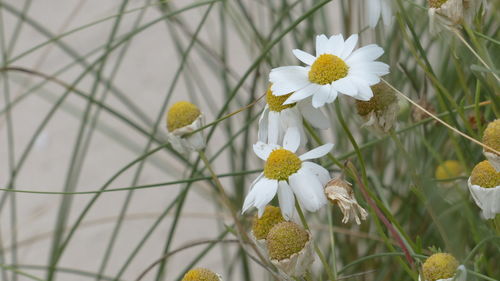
left=269, top=34, right=389, bottom=108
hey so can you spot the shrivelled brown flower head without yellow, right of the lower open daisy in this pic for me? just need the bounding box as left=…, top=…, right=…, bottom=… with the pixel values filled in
left=325, top=177, right=368, bottom=224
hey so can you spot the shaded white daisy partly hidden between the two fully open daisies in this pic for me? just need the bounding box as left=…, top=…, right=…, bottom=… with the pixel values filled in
left=258, top=86, right=329, bottom=145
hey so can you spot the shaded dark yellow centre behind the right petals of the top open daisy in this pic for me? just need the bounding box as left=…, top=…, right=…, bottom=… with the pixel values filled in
left=356, top=82, right=398, bottom=116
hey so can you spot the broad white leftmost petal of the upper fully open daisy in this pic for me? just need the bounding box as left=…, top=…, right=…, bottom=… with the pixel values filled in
left=269, top=66, right=310, bottom=96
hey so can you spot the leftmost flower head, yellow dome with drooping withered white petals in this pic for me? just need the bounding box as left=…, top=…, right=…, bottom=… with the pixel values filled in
left=167, top=101, right=205, bottom=154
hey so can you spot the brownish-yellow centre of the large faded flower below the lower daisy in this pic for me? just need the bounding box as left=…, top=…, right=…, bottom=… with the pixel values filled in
left=267, top=222, right=309, bottom=260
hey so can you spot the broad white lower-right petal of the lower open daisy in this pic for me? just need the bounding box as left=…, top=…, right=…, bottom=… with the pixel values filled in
left=289, top=169, right=326, bottom=212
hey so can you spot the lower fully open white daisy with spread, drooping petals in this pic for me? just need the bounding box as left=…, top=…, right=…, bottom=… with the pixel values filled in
left=242, top=127, right=333, bottom=220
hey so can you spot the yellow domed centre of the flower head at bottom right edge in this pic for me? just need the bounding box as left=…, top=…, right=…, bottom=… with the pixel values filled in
left=422, top=253, right=458, bottom=281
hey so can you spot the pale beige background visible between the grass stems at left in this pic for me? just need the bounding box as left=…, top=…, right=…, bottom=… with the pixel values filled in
left=0, top=0, right=354, bottom=281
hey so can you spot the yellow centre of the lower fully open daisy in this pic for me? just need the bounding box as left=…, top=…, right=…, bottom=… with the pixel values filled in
left=264, top=148, right=302, bottom=180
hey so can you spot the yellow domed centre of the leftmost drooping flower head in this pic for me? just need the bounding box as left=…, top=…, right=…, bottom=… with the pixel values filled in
left=167, top=101, right=201, bottom=132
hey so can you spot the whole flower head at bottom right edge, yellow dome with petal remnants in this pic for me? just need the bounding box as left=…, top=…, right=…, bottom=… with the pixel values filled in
left=418, top=253, right=467, bottom=281
